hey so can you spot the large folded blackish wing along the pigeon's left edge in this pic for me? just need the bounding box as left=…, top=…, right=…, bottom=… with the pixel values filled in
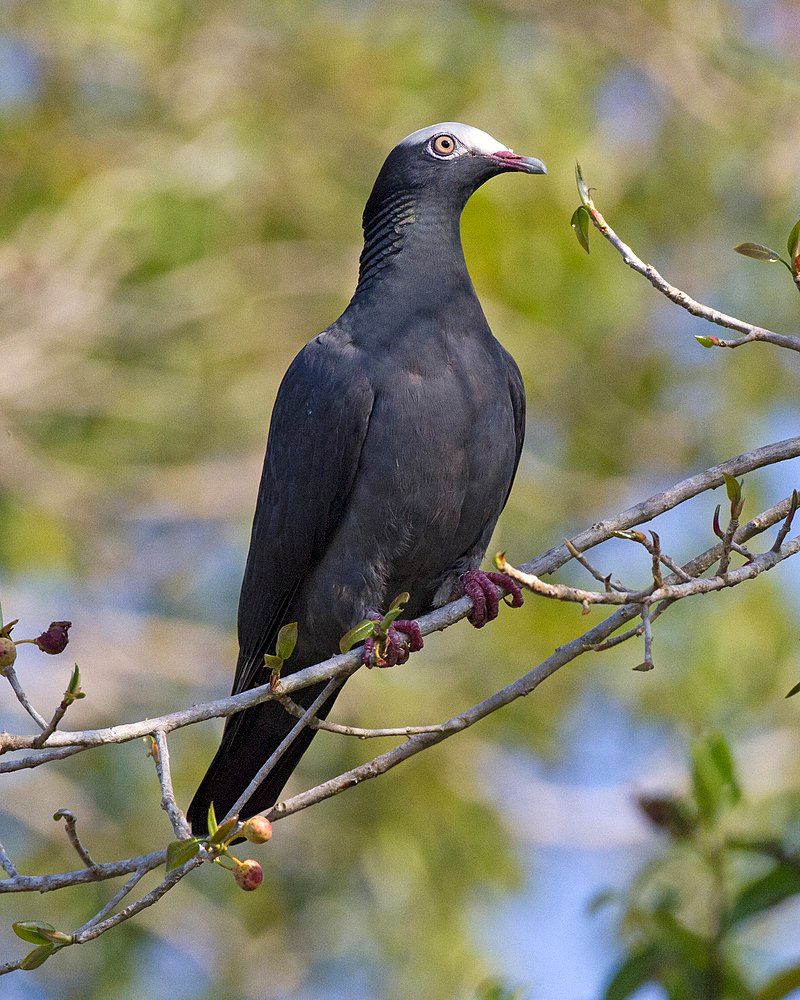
left=233, top=334, right=374, bottom=693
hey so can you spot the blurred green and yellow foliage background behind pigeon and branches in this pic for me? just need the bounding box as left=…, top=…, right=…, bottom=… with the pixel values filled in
left=0, top=0, right=800, bottom=1000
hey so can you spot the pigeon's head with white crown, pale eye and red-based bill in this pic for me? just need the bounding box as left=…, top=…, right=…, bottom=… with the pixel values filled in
left=368, top=122, right=547, bottom=215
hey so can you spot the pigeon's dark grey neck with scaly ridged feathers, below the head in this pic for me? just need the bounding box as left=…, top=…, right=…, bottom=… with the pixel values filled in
left=356, top=192, right=472, bottom=300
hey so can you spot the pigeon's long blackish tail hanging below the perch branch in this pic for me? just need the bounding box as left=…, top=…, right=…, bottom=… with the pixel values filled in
left=187, top=684, right=341, bottom=836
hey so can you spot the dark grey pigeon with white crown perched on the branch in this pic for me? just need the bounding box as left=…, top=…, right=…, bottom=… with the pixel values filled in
left=188, top=122, right=547, bottom=834
